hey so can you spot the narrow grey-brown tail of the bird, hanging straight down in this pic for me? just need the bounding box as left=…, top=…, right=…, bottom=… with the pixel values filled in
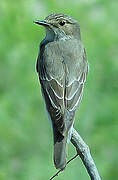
left=54, top=131, right=67, bottom=170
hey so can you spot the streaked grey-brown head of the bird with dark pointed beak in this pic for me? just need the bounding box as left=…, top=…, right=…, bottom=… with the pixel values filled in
left=35, top=14, right=80, bottom=39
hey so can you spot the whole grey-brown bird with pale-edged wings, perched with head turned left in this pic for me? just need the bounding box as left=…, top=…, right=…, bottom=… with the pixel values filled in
left=35, top=13, right=88, bottom=170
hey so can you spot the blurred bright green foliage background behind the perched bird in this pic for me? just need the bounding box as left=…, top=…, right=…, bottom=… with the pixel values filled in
left=0, top=0, right=118, bottom=180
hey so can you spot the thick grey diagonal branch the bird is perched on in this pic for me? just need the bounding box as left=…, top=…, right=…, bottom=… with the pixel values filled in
left=71, top=129, right=101, bottom=180
